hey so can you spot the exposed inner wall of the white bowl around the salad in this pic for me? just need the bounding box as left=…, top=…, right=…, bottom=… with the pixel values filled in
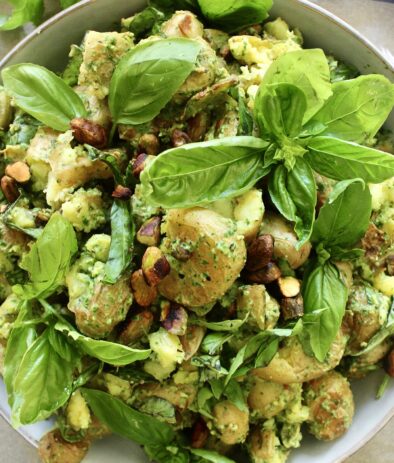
left=0, top=0, right=394, bottom=463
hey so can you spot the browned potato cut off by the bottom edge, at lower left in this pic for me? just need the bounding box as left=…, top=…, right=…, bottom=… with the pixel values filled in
left=38, top=429, right=90, bottom=463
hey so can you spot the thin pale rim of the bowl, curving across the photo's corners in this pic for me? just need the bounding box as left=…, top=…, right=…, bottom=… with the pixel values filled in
left=0, top=0, right=394, bottom=463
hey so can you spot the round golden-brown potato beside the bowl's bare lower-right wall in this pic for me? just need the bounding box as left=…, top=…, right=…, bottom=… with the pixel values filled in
left=305, top=371, right=354, bottom=441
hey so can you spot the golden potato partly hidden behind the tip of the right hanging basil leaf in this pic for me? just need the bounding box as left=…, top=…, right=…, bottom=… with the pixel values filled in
left=252, top=331, right=347, bottom=384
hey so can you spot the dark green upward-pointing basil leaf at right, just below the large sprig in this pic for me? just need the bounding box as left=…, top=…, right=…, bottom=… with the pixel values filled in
left=311, top=179, right=371, bottom=249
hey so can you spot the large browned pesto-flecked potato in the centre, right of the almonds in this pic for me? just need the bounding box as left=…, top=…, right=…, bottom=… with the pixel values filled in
left=158, top=207, right=246, bottom=307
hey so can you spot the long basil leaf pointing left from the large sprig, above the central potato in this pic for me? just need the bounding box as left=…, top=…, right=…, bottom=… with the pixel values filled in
left=141, top=137, right=268, bottom=208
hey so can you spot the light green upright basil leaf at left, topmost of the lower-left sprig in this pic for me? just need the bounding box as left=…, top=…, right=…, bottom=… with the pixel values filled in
left=14, top=213, right=78, bottom=299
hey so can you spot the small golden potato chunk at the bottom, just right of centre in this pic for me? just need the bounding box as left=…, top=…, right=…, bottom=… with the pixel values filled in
left=213, top=400, right=249, bottom=445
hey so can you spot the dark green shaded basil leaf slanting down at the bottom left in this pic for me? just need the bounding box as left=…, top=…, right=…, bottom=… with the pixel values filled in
left=81, top=388, right=175, bottom=447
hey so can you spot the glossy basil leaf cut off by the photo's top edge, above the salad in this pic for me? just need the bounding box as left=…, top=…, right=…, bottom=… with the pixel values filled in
left=198, top=0, right=272, bottom=32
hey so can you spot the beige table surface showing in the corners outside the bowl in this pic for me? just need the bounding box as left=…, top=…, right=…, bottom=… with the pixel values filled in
left=0, top=0, right=394, bottom=463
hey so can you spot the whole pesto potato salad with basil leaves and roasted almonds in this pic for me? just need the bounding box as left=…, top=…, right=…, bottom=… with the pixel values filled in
left=0, top=0, right=394, bottom=463
